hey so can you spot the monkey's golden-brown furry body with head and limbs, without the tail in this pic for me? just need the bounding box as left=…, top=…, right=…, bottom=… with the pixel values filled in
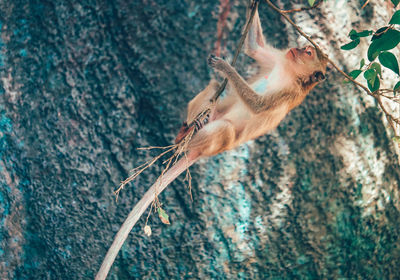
left=183, top=9, right=326, bottom=157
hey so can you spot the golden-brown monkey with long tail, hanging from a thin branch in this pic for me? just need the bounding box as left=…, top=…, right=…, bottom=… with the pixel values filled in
left=96, top=6, right=327, bottom=280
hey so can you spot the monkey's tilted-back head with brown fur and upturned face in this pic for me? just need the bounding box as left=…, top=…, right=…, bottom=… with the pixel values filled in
left=286, top=46, right=327, bottom=89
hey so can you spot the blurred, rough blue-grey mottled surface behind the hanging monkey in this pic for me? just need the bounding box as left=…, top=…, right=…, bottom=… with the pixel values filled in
left=0, top=0, right=400, bottom=279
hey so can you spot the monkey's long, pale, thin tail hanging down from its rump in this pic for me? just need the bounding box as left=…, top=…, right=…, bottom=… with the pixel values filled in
left=95, top=157, right=197, bottom=280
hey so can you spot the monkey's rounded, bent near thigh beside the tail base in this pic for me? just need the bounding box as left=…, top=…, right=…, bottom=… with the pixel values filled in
left=188, top=119, right=236, bottom=156
